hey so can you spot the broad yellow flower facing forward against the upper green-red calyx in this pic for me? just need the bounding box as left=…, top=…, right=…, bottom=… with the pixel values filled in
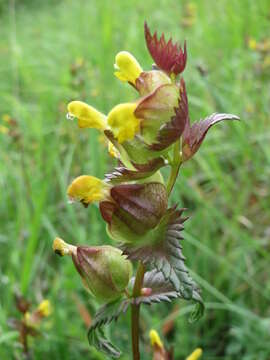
left=108, top=103, right=140, bottom=144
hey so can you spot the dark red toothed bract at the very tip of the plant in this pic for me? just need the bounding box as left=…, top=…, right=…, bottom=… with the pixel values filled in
left=144, top=22, right=187, bottom=75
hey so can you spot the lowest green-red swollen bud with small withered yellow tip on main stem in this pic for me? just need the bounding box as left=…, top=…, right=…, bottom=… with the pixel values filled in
left=53, top=238, right=132, bottom=302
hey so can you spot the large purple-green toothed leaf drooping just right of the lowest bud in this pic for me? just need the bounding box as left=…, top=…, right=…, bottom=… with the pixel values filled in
left=122, top=208, right=203, bottom=319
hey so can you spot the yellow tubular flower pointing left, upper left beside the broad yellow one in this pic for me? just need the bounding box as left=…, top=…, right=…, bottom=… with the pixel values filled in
left=68, top=101, right=107, bottom=130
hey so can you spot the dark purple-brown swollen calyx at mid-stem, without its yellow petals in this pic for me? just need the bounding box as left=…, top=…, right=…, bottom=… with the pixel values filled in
left=100, top=182, right=168, bottom=243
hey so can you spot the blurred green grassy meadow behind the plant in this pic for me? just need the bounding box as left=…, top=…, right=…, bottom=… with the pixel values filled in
left=0, top=0, right=270, bottom=360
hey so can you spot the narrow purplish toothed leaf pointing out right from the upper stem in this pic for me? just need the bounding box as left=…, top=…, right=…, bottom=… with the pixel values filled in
left=182, top=113, right=239, bottom=161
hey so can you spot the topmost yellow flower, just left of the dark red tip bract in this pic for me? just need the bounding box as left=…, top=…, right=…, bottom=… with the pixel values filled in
left=114, top=51, right=143, bottom=85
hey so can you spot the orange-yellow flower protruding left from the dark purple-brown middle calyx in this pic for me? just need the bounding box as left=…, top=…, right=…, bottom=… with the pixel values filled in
left=67, top=175, right=109, bottom=206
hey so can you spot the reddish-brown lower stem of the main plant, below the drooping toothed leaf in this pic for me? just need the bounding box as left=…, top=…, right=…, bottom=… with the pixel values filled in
left=131, top=261, right=145, bottom=360
